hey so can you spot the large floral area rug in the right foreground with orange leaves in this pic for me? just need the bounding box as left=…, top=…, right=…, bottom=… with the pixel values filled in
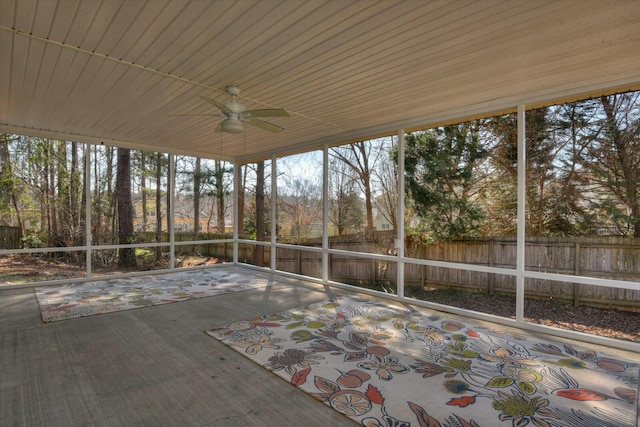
left=206, top=297, right=640, bottom=427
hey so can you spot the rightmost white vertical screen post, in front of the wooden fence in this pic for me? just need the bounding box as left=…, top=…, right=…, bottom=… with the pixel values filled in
left=516, top=104, right=527, bottom=322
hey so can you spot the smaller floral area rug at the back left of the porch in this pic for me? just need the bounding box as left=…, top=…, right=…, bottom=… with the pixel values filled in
left=35, top=268, right=271, bottom=322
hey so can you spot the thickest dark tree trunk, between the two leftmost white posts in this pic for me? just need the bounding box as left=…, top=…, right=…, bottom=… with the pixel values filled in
left=116, top=148, right=137, bottom=268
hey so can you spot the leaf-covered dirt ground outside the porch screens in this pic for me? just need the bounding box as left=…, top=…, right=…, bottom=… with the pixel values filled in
left=0, top=254, right=640, bottom=342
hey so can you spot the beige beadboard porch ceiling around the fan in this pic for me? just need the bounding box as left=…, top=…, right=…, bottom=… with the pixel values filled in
left=0, top=0, right=640, bottom=161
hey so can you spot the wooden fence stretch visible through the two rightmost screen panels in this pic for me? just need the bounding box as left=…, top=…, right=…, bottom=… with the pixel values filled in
left=405, top=237, right=640, bottom=309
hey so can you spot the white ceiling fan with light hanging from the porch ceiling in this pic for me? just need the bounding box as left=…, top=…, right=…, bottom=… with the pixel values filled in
left=201, top=86, right=289, bottom=133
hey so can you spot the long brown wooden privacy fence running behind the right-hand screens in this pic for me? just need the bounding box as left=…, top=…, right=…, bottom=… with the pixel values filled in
left=175, top=237, right=640, bottom=310
